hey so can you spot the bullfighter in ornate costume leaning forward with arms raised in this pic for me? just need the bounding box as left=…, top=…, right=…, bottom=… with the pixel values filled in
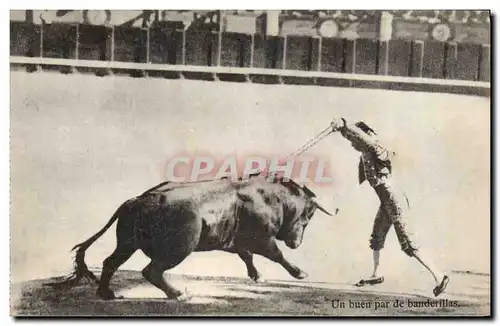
left=331, top=118, right=450, bottom=297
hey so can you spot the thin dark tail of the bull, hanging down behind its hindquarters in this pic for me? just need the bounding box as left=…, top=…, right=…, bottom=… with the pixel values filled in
left=45, top=205, right=124, bottom=288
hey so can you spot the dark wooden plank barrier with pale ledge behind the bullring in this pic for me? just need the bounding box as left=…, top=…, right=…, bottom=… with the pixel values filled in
left=10, top=22, right=490, bottom=93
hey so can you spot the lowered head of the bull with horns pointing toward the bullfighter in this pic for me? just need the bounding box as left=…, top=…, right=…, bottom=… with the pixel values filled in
left=276, top=181, right=338, bottom=249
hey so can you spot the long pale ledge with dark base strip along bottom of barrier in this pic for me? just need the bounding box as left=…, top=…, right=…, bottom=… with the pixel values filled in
left=10, top=57, right=490, bottom=96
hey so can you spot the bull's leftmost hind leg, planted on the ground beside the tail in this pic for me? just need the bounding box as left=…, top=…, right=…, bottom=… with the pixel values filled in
left=97, top=245, right=137, bottom=300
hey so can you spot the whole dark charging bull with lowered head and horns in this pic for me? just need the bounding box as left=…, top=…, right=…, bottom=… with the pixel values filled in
left=53, top=176, right=332, bottom=300
